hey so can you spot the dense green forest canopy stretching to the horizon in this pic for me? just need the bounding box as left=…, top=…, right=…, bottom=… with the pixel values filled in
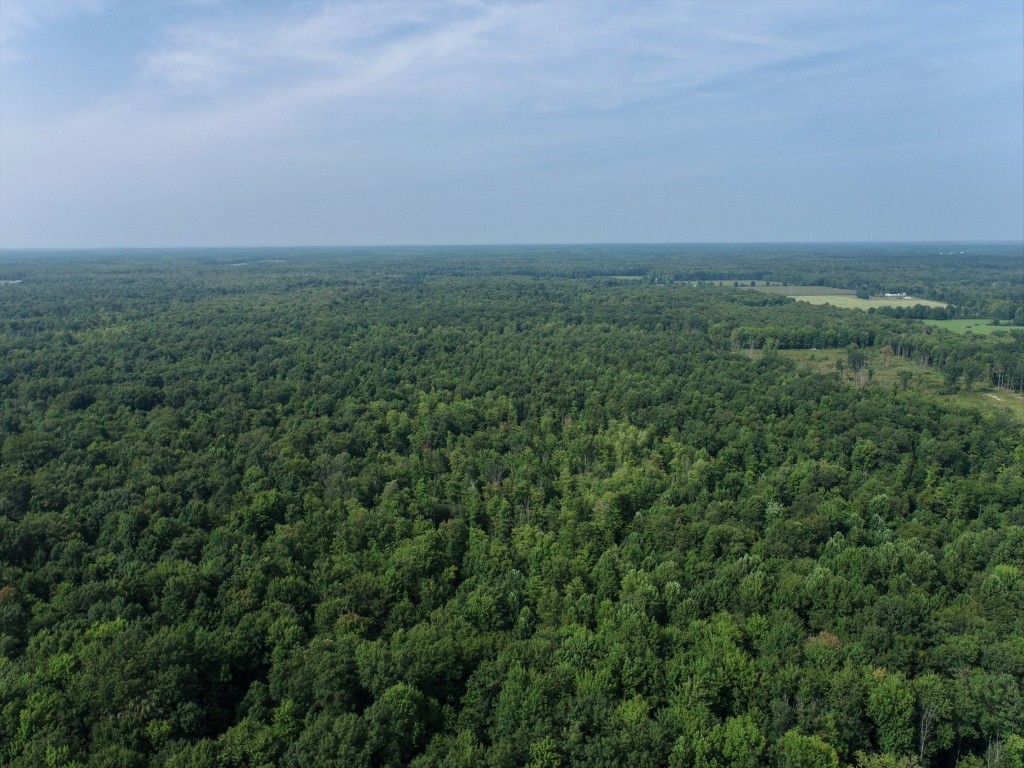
left=0, top=244, right=1024, bottom=768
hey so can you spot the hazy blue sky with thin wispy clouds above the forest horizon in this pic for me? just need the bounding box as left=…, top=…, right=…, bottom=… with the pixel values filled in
left=0, top=0, right=1024, bottom=249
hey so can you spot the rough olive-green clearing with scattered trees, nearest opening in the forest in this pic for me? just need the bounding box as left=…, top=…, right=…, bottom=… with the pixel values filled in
left=778, top=349, right=1024, bottom=421
